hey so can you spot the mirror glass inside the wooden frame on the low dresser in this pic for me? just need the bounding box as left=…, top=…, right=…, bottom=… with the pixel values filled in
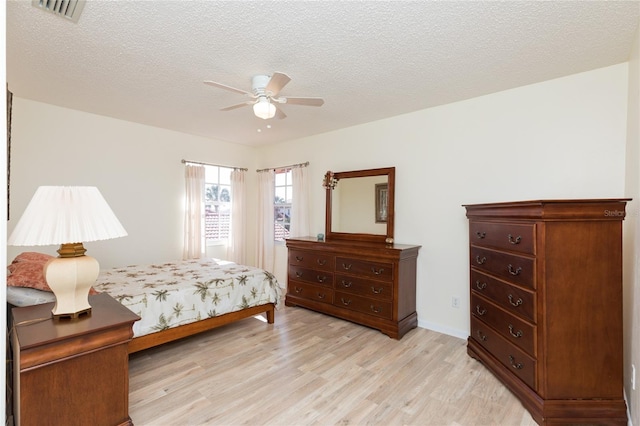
left=331, top=175, right=388, bottom=235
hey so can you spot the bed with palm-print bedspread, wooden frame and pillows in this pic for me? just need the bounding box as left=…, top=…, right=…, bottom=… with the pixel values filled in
left=7, top=253, right=282, bottom=353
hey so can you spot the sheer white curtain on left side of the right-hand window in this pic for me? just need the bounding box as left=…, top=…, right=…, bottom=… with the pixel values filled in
left=257, top=170, right=275, bottom=272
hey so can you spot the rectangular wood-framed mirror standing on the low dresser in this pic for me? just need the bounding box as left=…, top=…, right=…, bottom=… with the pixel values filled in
left=323, top=167, right=395, bottom=243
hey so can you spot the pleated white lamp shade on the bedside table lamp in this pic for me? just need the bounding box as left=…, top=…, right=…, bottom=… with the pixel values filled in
left=7, top=186, right=127, bottom=246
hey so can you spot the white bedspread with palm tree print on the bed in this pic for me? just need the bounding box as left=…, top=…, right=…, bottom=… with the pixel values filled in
left=94, top=259, right=282, bottom=337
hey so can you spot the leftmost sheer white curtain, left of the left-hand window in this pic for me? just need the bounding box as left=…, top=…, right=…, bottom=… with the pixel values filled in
left=182, top=164, right=205, bottom=260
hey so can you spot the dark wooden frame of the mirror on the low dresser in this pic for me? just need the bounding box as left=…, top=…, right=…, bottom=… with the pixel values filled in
left=325, top=167, right=396, bottom=244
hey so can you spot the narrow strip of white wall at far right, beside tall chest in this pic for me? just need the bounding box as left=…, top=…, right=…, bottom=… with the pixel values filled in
left=624, top=14, right=640, bottom=425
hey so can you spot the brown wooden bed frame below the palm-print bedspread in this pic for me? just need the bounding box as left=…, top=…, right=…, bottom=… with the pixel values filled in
left=129, top=303, right=275, bottom=354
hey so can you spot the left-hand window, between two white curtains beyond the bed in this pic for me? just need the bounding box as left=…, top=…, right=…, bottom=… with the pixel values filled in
left=204, top=166, right=233, bottom=244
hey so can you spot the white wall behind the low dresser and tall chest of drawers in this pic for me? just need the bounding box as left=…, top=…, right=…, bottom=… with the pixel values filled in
left=261, top=64, right=627, bottom=338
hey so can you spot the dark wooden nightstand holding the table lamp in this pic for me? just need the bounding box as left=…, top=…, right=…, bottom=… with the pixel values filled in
left=12, top=293, right=140, bottom=426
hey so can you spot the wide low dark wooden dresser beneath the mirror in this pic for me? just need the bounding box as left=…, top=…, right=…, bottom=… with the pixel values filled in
left=285, top=237, right=420, bottom=339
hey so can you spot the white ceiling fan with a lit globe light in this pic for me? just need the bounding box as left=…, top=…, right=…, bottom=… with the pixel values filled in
left=204, top=72, right=324, bottom=120
